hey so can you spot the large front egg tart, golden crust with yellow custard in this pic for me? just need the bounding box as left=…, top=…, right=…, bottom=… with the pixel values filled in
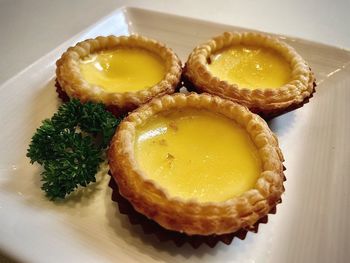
left=108, top=93, right=284, bottom=236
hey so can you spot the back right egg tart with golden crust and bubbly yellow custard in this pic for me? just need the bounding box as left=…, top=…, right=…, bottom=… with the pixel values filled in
left=184, top=32, right=316, bottom=118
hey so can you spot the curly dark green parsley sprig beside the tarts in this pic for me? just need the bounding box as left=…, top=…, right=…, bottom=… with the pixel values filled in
left=27, top=99, right=122, bottom=200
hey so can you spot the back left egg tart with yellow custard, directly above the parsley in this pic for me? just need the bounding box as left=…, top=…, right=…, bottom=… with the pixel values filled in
left=56, top=35, right=181, bottom=112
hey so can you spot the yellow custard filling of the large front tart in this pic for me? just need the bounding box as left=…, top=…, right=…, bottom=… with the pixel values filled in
left=134, top=109, right=261, bottom=202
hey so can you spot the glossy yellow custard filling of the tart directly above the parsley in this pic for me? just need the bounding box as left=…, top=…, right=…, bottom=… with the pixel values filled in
left=80, top=48, right=165, bottom=92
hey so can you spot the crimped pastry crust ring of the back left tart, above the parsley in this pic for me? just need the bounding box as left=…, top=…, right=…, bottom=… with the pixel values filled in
left=56, top=35, right=181, bottom=111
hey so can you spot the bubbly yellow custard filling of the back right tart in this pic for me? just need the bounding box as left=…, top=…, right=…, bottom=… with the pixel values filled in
left=208, top=45, right=291, bottom=89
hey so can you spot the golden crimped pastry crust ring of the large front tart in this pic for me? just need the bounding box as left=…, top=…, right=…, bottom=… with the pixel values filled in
left=108, top=93, right=284, bottom=235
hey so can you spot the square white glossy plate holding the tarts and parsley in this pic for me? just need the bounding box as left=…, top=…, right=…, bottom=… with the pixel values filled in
left=0, top=8, right=350, bottom=263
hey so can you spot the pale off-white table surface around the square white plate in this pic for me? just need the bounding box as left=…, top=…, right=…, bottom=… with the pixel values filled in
left=0, top=0, right=350, bottom=262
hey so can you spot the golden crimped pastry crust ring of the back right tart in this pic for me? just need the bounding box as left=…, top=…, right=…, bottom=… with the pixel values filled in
left=183, top=32, right=315, bottom=113
